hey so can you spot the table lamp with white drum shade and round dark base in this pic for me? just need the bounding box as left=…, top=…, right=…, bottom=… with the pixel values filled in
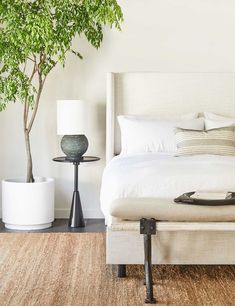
left=57, top=100, right=88, bottom=160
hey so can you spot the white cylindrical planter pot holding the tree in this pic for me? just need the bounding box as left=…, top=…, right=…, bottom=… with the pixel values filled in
left=2, top=178, right=54, bottom=230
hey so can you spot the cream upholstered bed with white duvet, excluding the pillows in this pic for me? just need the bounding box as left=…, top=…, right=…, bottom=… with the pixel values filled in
left=101, top=72, right=235, bottom=265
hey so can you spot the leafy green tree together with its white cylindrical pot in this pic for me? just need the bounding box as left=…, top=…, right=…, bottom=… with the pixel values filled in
left=0, top=0, right=123, bottom=230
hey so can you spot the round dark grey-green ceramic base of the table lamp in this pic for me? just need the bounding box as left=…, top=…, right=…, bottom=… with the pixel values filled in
left=61, top=135, right=88, bottom=159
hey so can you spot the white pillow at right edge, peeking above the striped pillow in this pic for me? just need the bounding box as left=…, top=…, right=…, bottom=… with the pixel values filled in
left=204, top=112, right=235, bottom=130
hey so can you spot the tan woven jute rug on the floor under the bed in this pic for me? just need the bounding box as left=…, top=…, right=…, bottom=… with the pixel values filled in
left=0, top=233, right=235, bottom=306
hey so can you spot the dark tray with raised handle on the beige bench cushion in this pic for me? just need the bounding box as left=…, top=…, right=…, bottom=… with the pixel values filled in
left=174, top=191, right=235, bottom=206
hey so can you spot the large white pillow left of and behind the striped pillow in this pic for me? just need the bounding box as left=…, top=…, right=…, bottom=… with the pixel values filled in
left=118, top=116, right=204, bottom=154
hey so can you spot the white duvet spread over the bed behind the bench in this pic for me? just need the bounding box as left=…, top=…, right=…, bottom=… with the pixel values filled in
left=101, top=153, right=235, bottom=217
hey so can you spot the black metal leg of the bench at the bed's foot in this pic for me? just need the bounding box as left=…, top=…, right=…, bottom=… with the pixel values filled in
left=140, top=218, right=156, bottom=304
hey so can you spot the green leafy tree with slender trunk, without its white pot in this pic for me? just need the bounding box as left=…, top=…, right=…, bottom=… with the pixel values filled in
left=0, top=0, right=123, bottom=182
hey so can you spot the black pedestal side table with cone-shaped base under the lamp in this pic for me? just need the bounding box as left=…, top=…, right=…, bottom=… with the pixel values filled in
left=53, top=156, right=100, bottom=228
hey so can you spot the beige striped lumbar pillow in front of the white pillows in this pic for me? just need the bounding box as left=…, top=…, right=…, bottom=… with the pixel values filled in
left=175, top=126, right=235, bottom=156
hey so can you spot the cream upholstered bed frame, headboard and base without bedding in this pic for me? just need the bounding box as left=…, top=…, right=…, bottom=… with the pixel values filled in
left=105, top=72, right=235, bottom=298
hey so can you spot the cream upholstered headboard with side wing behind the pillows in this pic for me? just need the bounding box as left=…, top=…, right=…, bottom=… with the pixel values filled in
left=106, top=72, right=235, bottom=161
